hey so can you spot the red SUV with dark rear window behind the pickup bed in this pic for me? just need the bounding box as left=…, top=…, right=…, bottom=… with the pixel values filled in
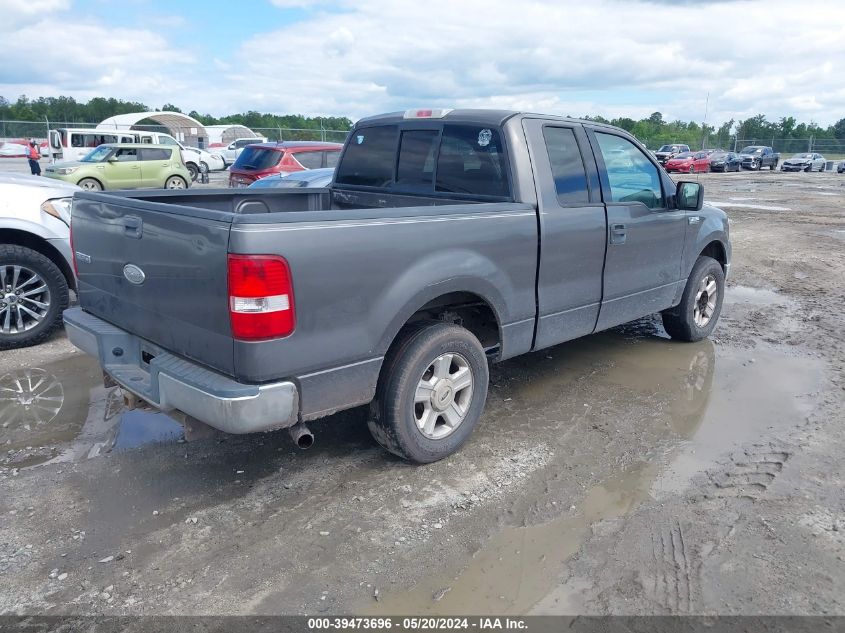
left=229, top=141, right=343, bottom=187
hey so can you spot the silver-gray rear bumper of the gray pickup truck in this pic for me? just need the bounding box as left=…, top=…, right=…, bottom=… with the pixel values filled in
left=64, top=308, right=299, bottom=433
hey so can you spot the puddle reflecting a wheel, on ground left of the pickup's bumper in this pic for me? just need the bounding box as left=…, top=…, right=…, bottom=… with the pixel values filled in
left=0, top=354, right=182, bottom=468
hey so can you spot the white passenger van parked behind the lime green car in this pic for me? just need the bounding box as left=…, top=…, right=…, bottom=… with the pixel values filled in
left=49, top=128, right=225, bottom=180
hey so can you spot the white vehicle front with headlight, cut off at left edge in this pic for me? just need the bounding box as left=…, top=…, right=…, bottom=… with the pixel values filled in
left=0, top=174, right=80, bottom=350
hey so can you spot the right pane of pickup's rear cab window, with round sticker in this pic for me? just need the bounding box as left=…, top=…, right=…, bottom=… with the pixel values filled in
left=435, top=125, right=510, bottom=197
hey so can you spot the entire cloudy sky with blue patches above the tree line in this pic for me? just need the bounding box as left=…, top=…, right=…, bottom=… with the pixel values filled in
left=0, top=0, right=845, bottom=125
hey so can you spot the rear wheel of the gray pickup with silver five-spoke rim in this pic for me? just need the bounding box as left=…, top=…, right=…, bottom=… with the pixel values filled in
left=368, top=322, right=489, bottom=464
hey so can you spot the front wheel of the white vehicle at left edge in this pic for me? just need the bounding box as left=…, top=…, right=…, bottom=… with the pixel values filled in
left=0, top=244, right=69, bottom=350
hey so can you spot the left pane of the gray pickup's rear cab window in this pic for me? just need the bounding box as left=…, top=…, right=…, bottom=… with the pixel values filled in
left=334, top=125, right=399, bottom=187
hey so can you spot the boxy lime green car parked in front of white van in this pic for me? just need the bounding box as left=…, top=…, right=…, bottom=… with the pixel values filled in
left=44, top=143, right=191, bottom=191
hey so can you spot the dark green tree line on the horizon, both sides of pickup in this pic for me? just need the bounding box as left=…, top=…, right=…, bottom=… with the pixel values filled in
left=0, top=95, right=845, bottom=149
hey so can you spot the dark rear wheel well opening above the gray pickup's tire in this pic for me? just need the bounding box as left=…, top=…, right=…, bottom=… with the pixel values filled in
left=405, top=292, right=502, bottom=356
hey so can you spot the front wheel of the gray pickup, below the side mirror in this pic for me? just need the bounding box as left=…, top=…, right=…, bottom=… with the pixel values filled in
left=662, top=257, right=725, bottom=342
